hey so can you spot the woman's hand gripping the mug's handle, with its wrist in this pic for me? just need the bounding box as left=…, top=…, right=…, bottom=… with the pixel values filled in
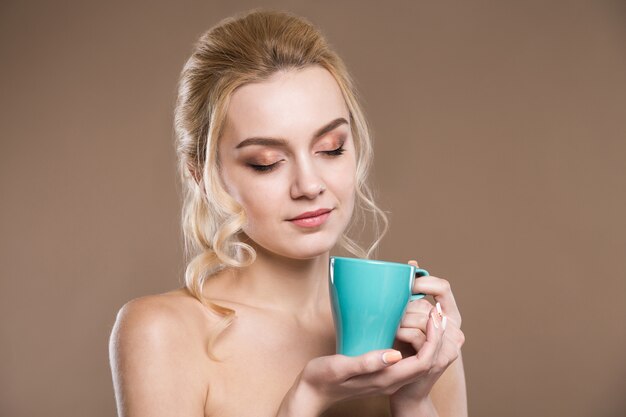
left=389, top=261, right=465, bottom=409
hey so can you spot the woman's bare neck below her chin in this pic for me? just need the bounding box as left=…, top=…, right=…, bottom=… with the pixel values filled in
left=224, top=245, right=329, bottom=315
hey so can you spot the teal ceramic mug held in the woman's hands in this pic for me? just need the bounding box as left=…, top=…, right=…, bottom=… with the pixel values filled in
left=329, top=256, right=428, bottom=356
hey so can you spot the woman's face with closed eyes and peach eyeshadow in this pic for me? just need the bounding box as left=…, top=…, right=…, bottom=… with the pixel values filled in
left=218, top=66, right=356, bottom=259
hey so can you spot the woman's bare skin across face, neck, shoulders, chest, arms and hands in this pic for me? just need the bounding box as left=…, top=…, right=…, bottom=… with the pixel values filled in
left=110, top=67, right=467, bottom=417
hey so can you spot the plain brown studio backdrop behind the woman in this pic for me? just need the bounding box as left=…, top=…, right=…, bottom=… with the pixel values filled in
left=0, top=0, right=626, bottom=417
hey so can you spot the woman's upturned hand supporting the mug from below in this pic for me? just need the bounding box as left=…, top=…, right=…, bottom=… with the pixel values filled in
left=278, top=308, right=447, bottom=415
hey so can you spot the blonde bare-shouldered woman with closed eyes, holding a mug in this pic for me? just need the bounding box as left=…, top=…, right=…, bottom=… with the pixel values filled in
left=110, top=10, right=467, bottom=417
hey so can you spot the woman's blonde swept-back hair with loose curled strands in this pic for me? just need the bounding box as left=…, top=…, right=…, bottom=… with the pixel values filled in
left=175, top=9, right=387, bottom=359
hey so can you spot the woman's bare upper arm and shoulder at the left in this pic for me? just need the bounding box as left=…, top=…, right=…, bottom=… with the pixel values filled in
left=109, top=297, right=207, bottom=417
